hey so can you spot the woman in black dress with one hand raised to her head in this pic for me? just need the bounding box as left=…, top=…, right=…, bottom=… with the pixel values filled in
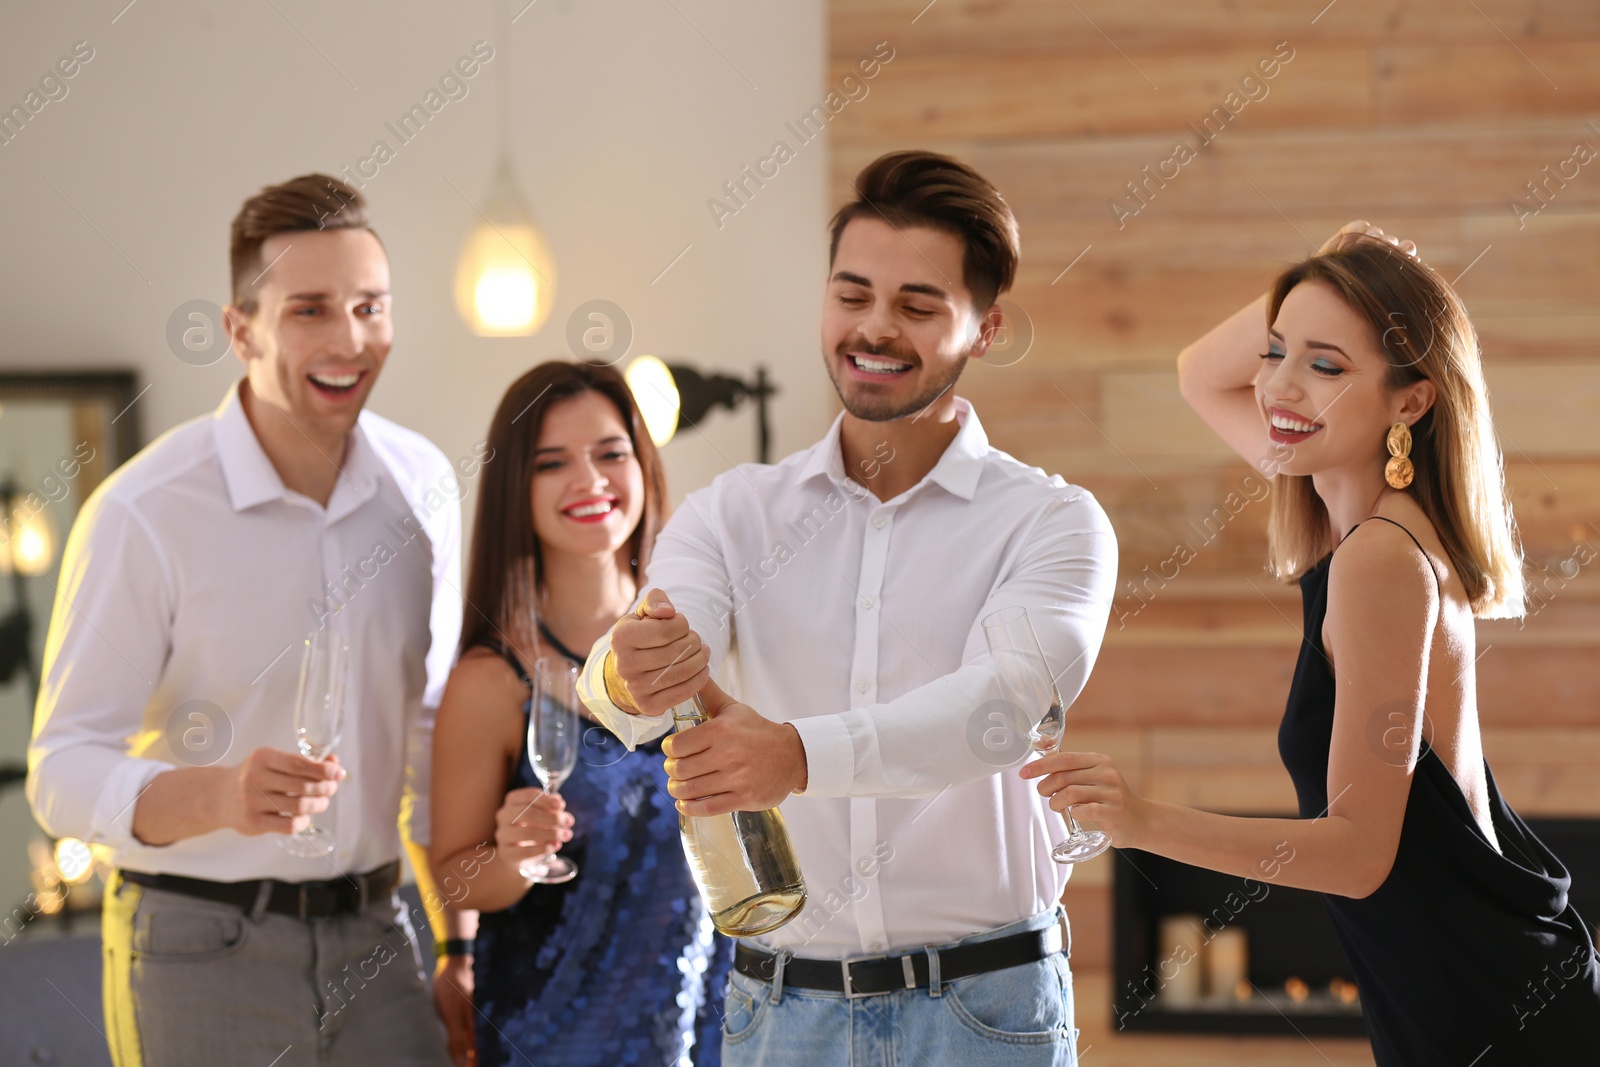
left=1022, top=222, right=1600, bottom=1067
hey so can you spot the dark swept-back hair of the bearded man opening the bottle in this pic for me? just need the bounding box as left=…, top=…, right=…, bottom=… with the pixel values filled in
left=827, top=152, right=1021, bottom=314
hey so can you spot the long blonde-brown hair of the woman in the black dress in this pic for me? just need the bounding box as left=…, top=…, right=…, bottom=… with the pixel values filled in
left=1267, top=237, right=1523, bottom=619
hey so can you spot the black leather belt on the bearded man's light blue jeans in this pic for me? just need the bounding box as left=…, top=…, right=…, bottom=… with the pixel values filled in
left=733, top=923, right=1062, bottom=998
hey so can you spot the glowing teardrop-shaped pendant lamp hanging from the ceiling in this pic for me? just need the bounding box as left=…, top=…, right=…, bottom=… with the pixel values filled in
left=456, top=0, right=555, bottom=338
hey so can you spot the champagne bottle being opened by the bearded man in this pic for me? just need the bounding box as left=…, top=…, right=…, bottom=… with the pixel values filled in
left=672, top=696, right=805, bottom=937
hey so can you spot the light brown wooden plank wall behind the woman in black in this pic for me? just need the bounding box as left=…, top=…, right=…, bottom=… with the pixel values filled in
left=829, top=0, right=1600, bottom=968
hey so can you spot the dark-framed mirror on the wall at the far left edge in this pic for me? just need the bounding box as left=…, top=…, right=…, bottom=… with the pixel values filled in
left=0, top=371, right=141, bottom=921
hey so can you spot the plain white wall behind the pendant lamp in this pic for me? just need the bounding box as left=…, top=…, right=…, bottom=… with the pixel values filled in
left=0, top=0, right=832, bottom=905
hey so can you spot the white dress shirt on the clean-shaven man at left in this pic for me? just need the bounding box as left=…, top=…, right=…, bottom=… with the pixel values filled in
left=27, top=386, right=461, bottom=881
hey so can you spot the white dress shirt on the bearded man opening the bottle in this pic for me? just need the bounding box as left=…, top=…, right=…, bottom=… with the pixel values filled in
left=581, top=400, right=1117, bottom=958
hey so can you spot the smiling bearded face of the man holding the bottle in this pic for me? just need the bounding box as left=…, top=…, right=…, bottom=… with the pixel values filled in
left=822, top=218, right=998, bottom=422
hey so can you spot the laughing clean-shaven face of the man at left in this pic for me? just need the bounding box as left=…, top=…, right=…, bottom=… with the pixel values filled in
left=229, top=229, right=394, bottom=438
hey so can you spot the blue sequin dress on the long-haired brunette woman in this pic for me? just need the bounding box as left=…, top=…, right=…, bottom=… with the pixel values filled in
left=472, top=635, right=733, bottom=1067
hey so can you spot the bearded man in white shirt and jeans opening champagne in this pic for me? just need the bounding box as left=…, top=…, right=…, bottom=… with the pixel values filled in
left=582, top=152, right=1117, bottom=1067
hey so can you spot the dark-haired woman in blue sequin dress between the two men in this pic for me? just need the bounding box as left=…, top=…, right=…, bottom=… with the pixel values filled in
left=430, top=363, right=731, bottom=1067
